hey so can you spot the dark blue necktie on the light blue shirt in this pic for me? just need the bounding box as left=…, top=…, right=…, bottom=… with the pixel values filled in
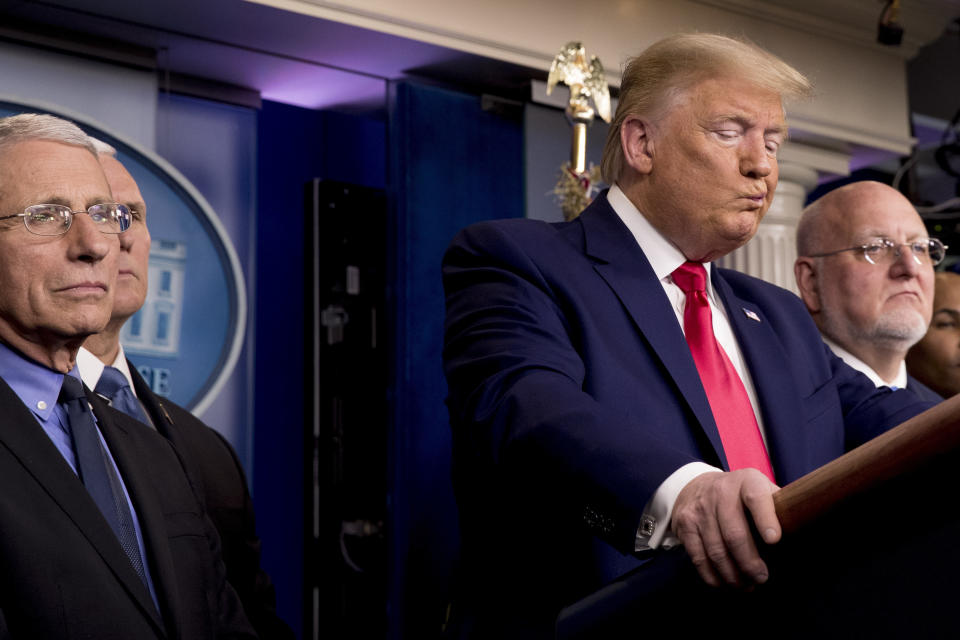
left=58, top=375, right=149, bottom=589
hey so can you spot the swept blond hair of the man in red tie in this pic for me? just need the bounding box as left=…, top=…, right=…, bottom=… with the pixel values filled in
left=601, top=33, right=812, bottom=184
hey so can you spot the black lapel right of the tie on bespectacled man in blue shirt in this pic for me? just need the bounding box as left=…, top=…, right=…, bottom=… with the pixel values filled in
left=94, top=393, right=179, bottom=637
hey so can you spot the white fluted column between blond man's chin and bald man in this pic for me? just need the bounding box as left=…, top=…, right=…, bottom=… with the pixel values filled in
left=718, top=162, right=817, bottom=293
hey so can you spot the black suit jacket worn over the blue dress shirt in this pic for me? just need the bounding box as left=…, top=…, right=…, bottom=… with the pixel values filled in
left=0, top=379, right=256, bottom=640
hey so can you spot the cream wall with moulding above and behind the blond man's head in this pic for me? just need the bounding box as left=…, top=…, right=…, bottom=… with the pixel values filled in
left=260, top=0, right=912, bottom=154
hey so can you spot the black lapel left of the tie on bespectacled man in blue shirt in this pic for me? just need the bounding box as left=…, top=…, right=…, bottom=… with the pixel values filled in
left=0, top=380, right=163, bottom=634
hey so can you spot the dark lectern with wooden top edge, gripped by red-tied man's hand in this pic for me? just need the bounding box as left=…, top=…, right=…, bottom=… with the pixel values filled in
left=557, top=396, right=960, bottom=640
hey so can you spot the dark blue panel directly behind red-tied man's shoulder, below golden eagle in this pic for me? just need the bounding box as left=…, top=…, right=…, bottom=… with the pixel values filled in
left=388, top=83, right=524, bottom=638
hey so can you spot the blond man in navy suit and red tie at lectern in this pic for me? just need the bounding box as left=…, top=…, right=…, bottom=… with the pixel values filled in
left=443, top=34, right=929, bottom=638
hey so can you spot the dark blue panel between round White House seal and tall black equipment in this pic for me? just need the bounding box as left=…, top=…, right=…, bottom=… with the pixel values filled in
left=253, top=101, right=386, bottom=637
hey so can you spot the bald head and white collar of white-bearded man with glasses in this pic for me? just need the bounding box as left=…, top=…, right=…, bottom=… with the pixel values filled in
left=794, top=181, right=946, bottom=400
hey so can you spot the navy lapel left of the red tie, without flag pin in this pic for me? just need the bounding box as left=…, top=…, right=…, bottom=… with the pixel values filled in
left=579, top=195, right=727, bottom=468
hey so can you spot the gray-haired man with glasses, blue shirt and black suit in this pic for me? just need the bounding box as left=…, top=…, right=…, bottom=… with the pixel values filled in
left=0, top=114, right=255, bottom=640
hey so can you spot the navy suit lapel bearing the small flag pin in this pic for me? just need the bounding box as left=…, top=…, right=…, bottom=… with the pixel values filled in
left=711, top=269, right=807, bottom=485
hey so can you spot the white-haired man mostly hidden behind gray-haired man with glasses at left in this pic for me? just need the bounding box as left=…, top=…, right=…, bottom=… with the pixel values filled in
left=77, top=140, right=293, bottom=640
